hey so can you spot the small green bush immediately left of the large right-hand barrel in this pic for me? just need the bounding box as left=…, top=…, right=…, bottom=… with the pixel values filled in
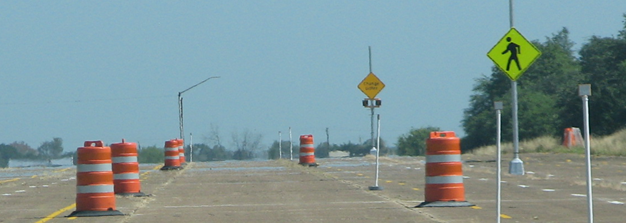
left=396, top=126, right=440, bottom=156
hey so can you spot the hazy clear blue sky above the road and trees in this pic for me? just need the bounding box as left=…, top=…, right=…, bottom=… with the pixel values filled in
left=0, top=0, right=626, bottom=151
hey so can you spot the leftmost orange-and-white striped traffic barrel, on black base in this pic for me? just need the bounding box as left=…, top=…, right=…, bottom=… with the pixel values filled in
left=68, top=141, right=124, bottom=217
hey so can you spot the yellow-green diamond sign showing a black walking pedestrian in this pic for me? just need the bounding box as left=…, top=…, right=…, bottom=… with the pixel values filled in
left=488, top=28, right=542, bottom=81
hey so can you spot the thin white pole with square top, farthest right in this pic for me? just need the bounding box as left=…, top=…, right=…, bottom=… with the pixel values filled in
left=579, top=84, right=594, bottom=223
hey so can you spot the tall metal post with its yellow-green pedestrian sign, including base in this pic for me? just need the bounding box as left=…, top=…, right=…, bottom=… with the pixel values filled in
left=488, top=0, right=542, bottom=175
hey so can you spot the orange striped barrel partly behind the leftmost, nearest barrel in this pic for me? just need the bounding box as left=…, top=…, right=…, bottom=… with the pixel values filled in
left=111, top=139, right=146, bottom=197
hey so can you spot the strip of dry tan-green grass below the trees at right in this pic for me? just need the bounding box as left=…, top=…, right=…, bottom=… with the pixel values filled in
left=471, top=129, right=627, bottom=156
